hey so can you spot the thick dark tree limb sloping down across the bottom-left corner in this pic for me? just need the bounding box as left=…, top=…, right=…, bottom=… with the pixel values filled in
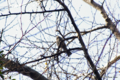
left=0, top=58, right=48, bottom=80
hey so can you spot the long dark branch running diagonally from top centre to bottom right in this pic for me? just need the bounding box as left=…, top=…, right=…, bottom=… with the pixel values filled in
left=56, top=0, right=101, bottom=80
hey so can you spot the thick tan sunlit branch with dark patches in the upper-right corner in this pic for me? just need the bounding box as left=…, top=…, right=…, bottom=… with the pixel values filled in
left=83, top=0, right=120, bottom=41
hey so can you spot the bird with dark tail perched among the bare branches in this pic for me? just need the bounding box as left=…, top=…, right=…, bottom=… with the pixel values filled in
left=56, top=36, right=72, bottom=57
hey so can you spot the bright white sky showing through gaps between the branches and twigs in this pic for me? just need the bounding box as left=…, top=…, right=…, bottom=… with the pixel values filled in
left=0, top=0, right=120, bottom=80
